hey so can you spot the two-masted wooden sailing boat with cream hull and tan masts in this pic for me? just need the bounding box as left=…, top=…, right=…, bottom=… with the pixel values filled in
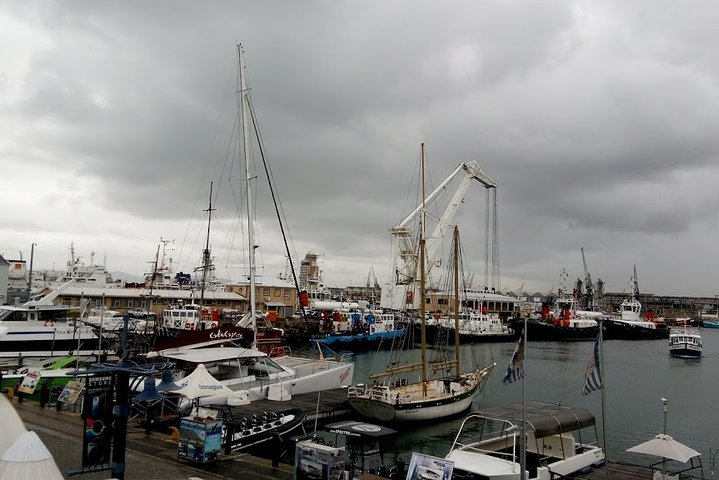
left=347, top=144, right=494, bottom=423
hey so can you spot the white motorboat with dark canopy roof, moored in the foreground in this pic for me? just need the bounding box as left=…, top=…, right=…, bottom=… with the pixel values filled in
left=446, top=401, right=604, bottom=480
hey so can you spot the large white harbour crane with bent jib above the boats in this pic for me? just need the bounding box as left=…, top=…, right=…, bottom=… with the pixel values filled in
left=381, top=161, right=497, bottom=310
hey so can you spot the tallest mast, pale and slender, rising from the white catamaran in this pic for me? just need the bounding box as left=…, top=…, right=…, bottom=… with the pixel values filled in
left=237, top=44, right=257, bottom=348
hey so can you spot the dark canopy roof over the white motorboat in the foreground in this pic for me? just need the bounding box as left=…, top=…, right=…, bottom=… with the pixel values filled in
left=476, top=401, right=595, bottom=438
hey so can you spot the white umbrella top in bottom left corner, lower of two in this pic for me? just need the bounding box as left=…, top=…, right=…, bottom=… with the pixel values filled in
left=0, top=432, right=63, bottom=480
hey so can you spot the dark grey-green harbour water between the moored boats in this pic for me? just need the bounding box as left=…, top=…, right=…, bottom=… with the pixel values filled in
left=348, top=329, right=719, bottom=468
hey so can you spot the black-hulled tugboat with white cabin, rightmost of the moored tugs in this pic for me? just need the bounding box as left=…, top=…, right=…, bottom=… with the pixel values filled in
left=602, top=265, right=669, bottom=340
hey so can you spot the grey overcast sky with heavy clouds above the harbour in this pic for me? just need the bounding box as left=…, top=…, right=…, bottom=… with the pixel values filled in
left=0, top=0, right=719, bottom=296
